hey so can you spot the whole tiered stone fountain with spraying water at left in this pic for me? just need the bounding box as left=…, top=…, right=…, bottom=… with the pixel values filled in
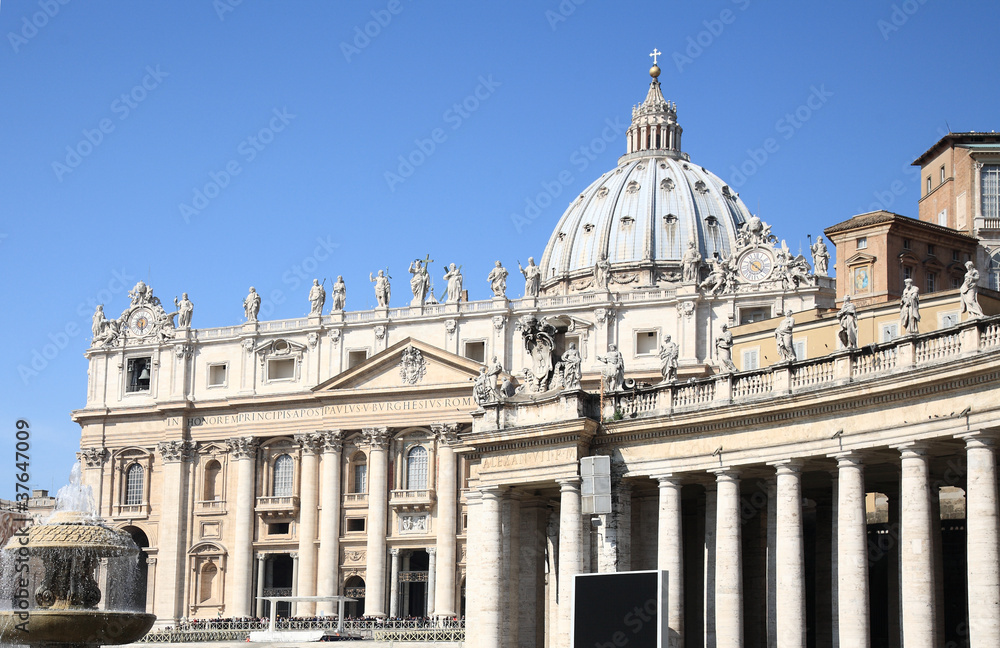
left=0, top=464, right=156, bottom=648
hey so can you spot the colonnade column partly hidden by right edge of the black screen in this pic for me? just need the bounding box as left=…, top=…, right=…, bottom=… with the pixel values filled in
left=656, top=475, right=684, bottom=648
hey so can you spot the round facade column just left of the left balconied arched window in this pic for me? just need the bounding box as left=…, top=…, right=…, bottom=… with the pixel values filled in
left=226, top=436, right=257, bottom=617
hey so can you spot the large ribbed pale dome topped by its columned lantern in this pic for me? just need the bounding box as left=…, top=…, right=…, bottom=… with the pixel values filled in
left=539, top=66, right=751, bottom=294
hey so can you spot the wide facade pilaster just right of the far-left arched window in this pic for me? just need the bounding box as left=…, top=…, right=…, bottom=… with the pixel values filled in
left=153, top=441, right=196, bottom=622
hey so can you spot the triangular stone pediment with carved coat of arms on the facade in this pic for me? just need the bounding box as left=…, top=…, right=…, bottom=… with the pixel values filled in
left=313, top=338, right=482, bottom=392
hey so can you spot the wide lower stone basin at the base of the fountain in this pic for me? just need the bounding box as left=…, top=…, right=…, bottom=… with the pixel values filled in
left=0, top=609, right=156, bottom=648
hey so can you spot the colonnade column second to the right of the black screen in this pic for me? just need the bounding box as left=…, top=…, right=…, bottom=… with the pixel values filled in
left=715, top=470, right=743, bottom=648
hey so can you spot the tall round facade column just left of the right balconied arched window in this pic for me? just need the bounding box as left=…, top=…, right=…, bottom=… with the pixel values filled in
left=362, top=427, right=389, bottom=617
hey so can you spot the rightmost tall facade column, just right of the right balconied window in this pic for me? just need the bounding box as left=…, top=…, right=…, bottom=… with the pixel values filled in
left=428, top=424, right=458, bottom=618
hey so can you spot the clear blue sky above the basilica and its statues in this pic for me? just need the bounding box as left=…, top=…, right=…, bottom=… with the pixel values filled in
left=0, top=0, right=1000, bottom=498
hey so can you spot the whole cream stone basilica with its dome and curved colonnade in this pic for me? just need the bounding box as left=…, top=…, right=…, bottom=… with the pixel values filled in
left=73, top=60, right=1000, bottom=648
